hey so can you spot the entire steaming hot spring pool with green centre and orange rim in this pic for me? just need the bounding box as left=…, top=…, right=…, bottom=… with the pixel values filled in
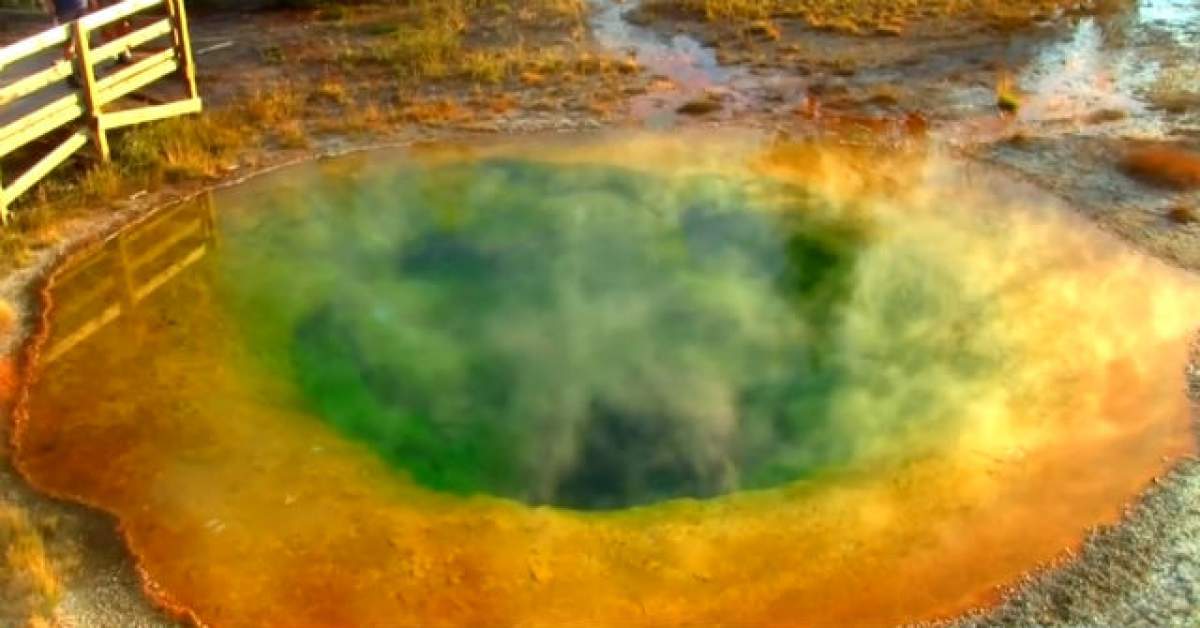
left=16, top=136, right=1200, bottom=627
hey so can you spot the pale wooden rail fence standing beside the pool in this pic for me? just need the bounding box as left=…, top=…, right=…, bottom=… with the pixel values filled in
left=0, top=0, right=200, bottom=223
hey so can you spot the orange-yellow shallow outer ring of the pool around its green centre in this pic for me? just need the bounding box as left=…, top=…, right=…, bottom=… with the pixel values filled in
left=14, top=140, right=1200, bottom=628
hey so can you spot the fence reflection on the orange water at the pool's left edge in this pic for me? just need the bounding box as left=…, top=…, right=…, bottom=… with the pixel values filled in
left=43, top=196, right=216, bottom=364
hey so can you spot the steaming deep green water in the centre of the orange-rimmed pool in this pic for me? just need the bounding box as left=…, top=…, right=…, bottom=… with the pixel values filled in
left=213, top=153, right=1000, bottom=509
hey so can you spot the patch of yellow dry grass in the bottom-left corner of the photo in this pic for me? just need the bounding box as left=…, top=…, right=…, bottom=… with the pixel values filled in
left=0, top=503, right=62, bottom=627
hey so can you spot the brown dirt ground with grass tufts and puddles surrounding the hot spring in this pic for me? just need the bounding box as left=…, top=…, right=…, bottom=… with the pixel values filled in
left=0, top=0, right=1200, bottom=627
